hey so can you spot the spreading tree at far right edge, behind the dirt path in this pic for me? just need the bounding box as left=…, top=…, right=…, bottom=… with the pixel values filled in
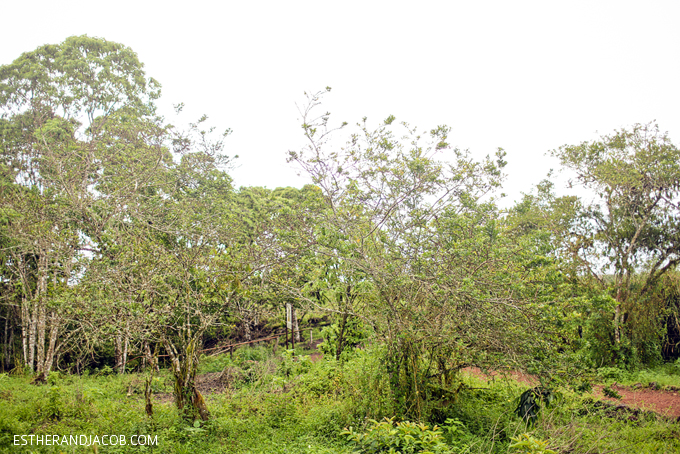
left=552, top=124, right=680, bottom=352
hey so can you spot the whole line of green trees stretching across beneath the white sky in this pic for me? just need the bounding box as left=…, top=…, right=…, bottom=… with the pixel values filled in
left=0, top=36, right=680, bottom=419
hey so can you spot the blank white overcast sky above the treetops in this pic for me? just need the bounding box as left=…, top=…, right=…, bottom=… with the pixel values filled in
left=0, top=0, right=680, bottom=207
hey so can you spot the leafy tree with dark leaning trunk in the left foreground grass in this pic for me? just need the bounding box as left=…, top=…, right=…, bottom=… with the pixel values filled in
left=79, top=111, right=244, bottom=419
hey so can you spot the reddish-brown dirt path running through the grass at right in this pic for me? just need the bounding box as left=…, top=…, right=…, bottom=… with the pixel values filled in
left=463, top=367, right=680, bottom=418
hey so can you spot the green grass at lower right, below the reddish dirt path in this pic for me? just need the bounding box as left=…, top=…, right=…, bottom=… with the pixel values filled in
left=455, top=371, right=680, bottom=454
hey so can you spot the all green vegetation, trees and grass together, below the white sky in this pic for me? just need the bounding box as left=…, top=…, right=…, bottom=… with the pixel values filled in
left=0, top=36, right=680, bottom=453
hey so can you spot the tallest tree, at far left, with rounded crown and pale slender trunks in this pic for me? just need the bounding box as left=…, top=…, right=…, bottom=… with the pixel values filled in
left=0, top=36, right=159, bottom=379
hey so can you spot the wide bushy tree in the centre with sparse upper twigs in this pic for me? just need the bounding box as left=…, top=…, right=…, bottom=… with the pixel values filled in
left=290, top=89, right=556, bottom=417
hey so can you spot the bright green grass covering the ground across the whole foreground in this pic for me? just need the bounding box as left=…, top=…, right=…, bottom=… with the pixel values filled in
left=0, top=346, right=680, bottom=454
